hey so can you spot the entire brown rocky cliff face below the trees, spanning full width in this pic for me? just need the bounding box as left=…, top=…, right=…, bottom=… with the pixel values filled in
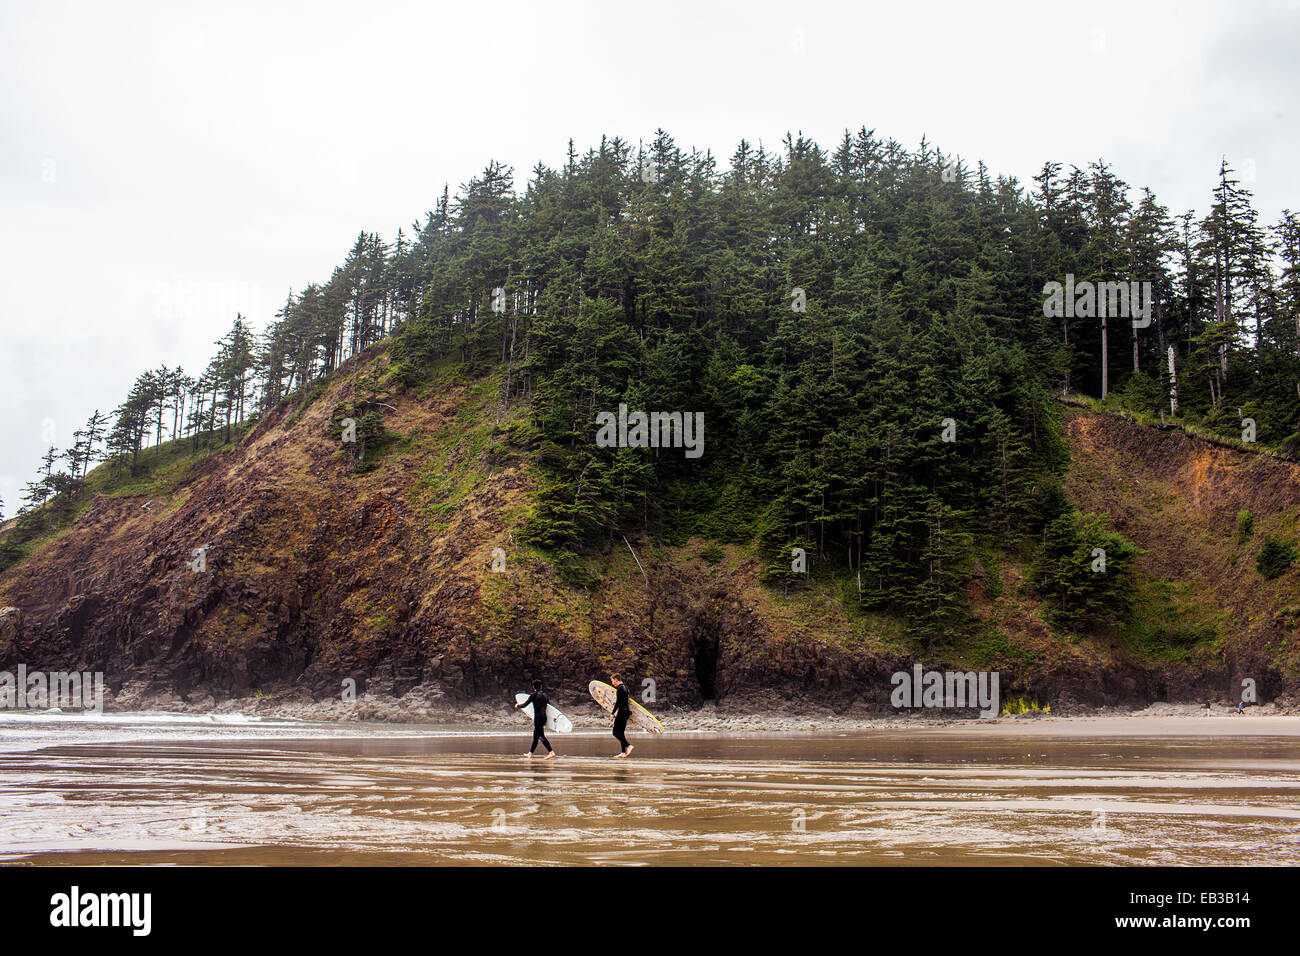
left=0, top=350, right=1300, bottom=710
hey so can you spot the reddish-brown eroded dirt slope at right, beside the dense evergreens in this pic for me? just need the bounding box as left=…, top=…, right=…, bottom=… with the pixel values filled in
left=1066, top=410, right=1300, bottom=697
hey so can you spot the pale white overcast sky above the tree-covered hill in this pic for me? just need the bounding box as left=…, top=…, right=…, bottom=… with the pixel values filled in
left=0, top=0, right=1300, bottom=515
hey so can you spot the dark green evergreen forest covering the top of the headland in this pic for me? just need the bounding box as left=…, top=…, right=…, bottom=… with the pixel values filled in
left=0, top=129, right=1300, bottom=702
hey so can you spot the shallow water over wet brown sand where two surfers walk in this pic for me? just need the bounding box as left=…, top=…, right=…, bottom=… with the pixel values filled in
left=0, top=715, right=1300, bottom=865
